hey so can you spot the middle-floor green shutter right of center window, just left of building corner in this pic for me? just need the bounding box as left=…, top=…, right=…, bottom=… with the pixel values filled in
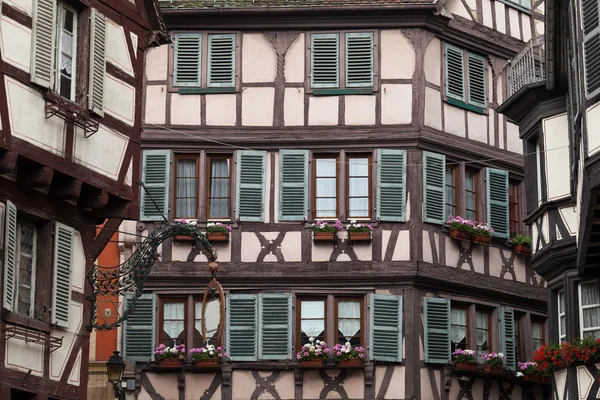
left=377, top=149, right=406, bottom=222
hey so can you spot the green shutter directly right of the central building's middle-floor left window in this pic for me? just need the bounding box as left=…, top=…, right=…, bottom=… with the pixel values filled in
left=235, top=150, right=267, bottom=222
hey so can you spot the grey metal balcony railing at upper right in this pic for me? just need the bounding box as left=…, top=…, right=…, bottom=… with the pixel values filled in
left=509, top=36, right=546, bottom=97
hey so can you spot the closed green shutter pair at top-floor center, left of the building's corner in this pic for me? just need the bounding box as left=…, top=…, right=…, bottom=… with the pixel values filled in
left=310, top=32, right=374, bottom=89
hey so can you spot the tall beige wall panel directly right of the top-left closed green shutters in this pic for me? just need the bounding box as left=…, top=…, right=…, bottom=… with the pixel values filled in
left=242, top=33, right=277, bottom=82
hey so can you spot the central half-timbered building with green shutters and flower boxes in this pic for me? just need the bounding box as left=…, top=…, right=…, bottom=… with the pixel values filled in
left=116, top=0, right=549, bottom=399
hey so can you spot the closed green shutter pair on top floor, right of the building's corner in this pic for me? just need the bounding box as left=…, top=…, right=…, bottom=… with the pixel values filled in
left=445, top=44, right=487, bottom=113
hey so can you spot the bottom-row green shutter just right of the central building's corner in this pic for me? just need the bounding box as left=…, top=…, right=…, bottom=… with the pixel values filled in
left=423, top=297, right=450, bottom=364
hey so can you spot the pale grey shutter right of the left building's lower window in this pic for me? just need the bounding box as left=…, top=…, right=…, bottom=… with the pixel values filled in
left=52, top=222, right=74, bottom=328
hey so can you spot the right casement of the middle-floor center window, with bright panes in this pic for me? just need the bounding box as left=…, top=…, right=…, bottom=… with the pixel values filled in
left=347, top=156, right=371, bottom=219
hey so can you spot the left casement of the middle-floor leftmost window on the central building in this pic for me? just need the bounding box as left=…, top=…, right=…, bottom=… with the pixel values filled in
left=175, top=155, right=198, bottom=218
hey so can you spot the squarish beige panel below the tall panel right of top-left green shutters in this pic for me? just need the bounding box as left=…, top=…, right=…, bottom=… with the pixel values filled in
left=242, top=88, right=275, bottom=126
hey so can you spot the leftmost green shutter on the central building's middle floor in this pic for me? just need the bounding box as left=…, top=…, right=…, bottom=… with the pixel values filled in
left=140, top=150, right=171, bottom=221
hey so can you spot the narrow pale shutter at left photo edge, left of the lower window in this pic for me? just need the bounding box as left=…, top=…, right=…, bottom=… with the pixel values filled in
left=2, top=200, right=18, bottom=311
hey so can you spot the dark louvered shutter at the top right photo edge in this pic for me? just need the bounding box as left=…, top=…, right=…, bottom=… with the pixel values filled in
left=582, top=0, right=600, bottom=98
